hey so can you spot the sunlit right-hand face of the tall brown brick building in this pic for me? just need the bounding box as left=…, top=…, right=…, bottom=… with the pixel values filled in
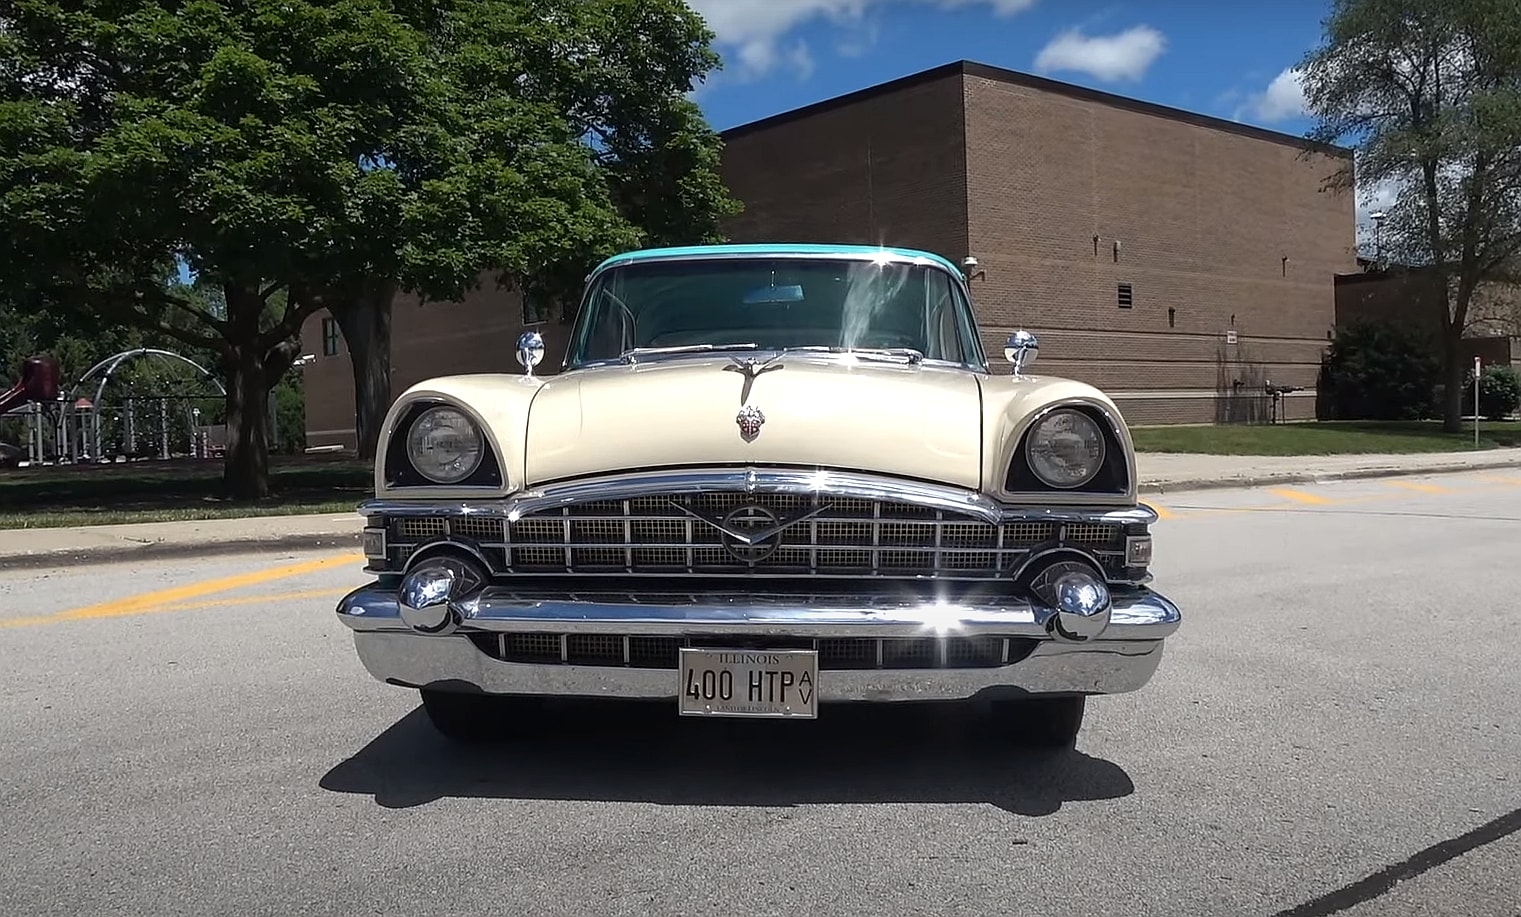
left=964, top=71, right=1355, bottom=423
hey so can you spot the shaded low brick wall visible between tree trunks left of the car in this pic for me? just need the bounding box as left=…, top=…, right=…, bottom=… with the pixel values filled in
left=301, top=278, right=570, bottom=449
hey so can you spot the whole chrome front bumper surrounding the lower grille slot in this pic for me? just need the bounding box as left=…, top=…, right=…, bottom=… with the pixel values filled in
left=338, top=582, right=1182, bottom=703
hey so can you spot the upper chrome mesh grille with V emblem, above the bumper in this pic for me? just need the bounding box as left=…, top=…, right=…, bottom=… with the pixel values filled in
left=374, top=491, right=1124, bottom=579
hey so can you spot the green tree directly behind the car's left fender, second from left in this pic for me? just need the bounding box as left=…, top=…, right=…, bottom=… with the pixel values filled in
left=330, top=0, right=738, bottom=458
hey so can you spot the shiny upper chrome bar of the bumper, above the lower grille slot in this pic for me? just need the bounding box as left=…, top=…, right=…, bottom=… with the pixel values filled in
left=336, top=584, right=1183, bottom=640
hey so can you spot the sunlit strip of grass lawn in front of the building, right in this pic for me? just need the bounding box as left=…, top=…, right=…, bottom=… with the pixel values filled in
left=1130, top=421, right=1521, bottom=455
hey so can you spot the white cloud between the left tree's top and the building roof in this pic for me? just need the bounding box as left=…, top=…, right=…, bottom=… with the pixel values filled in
left=687, top=0, right=1036, bottom=79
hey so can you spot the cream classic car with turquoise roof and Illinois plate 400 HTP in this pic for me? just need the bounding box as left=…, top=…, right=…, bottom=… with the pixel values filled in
left=338, top=245, right=1180, bottom=747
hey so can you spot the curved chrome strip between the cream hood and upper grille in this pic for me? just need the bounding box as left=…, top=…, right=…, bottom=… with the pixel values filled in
left=359, top=468, right=1157, bottom=526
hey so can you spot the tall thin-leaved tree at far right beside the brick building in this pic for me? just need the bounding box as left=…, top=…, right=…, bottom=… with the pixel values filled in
left=1300, top=0, right=1521, bottom=432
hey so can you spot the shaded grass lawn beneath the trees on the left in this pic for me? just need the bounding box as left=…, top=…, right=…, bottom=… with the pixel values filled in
left=0, top=456, right=373, bottom=529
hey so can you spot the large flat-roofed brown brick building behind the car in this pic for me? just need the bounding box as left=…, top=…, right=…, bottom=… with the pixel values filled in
left=304, top=61, right=1357, bottom=446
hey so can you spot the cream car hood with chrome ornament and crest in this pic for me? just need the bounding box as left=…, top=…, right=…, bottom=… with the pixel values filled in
left=525, top=354, right=983, bottom=488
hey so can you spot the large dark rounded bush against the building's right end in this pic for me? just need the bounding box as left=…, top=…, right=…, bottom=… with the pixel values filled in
left=1319, top=321, right=1442, bottom=420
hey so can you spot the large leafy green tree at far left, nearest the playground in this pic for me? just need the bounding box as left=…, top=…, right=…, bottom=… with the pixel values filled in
left=0, top=0, right=736, bottom=497
